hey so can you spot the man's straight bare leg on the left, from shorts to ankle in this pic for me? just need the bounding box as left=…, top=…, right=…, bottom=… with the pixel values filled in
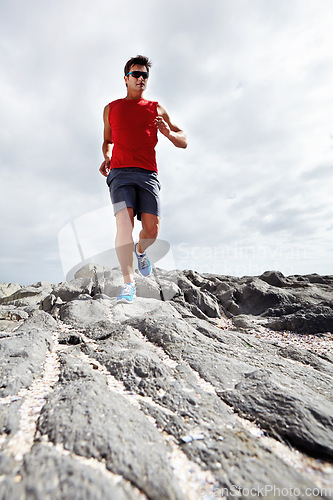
left=116, top=208, right=134, bottom=283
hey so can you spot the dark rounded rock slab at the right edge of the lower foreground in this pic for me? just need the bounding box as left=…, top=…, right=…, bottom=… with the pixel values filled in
left=220, top=370, right=333, bottom=460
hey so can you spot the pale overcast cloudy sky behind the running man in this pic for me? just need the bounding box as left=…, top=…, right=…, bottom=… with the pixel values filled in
left=0, top=0, right=333, bottom=284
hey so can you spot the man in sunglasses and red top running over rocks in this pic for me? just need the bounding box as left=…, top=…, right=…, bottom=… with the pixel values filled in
left=100, top=55, right=187, bottom=303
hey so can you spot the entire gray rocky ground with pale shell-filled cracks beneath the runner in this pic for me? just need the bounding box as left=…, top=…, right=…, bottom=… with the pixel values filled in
left=0, top=264, right=333, bottom=500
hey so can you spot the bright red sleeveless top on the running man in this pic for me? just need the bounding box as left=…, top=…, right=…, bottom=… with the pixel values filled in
left=109, top=99, right=158, bottom=172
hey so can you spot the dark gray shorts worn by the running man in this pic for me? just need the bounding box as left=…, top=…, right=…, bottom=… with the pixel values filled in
left=106, top=167, right=161, bottom=220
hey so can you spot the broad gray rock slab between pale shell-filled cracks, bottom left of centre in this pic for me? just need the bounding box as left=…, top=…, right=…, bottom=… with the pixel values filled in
left=38, top=357, right=183, bottom=499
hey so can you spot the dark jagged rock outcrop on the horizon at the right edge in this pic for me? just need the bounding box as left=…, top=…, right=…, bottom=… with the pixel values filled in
left=187, top=271, right=333, bottom=334
